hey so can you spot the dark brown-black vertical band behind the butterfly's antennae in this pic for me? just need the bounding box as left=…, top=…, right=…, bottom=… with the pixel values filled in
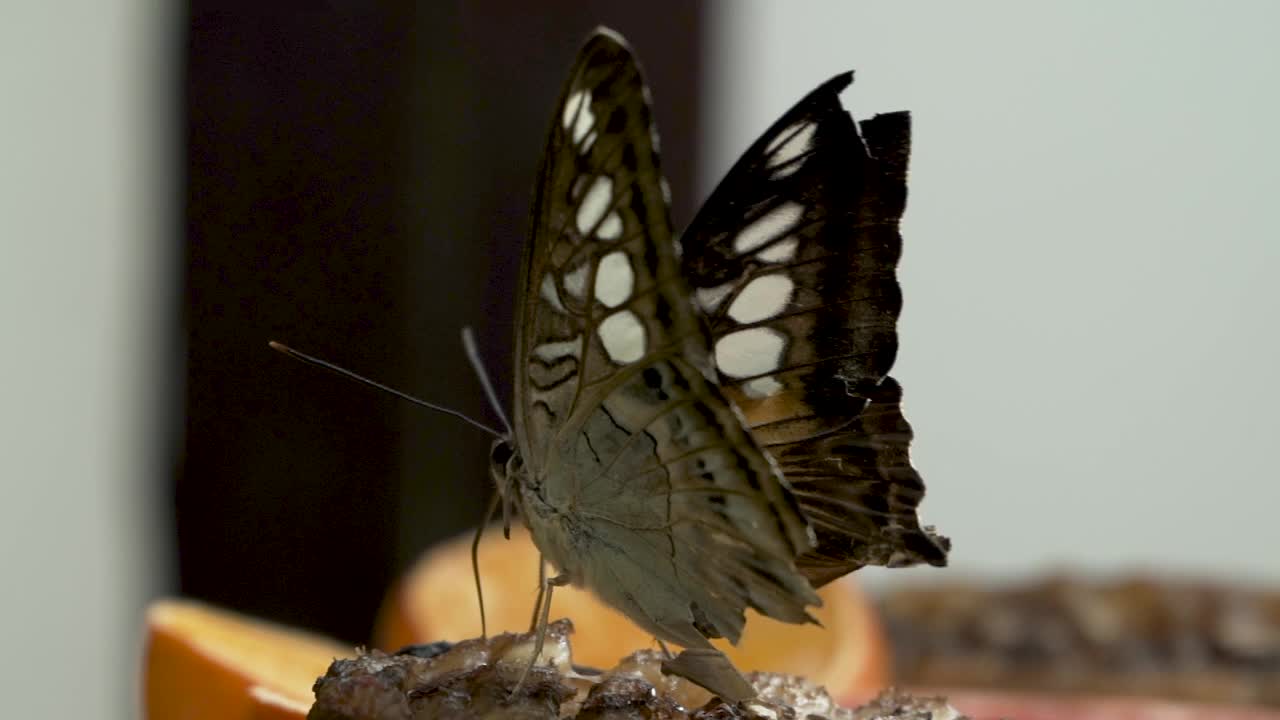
left=174, top=0, right=701, bottom=642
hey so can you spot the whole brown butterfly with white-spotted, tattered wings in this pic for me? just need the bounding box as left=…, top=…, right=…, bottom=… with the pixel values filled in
left=490, top=28, right=950, bottom=696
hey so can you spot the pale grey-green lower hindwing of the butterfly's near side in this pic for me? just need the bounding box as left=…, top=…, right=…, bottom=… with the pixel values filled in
left=499, top=345, right=817, bottom=647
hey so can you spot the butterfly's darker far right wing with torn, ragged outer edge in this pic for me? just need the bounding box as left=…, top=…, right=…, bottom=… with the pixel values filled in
left=681, top=73, right=948, bottom=587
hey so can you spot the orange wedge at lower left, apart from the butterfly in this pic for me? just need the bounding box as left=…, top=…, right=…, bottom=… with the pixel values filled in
left=143, top=600, right=353, bottom=720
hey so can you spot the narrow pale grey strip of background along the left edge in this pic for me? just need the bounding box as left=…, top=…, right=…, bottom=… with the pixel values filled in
left=0, top=0, right=172, bottom=719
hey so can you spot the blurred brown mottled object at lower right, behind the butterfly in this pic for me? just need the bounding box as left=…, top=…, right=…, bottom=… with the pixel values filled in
left=881, top=577, right=1280, bottom=706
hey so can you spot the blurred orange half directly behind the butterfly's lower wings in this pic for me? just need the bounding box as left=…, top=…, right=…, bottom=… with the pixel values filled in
left=374, top=528, right=891, bottom=700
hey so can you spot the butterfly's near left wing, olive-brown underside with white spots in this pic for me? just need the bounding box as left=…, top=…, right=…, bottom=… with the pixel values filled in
left=516, top=31, right=818, bottom=647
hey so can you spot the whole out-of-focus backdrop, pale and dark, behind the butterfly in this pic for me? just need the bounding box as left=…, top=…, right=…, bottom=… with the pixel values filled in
left=0, top=0, right=1280, bottom=717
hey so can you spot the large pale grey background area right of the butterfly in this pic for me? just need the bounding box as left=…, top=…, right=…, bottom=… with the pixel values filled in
left=706, top=1, right=1280, bottom=582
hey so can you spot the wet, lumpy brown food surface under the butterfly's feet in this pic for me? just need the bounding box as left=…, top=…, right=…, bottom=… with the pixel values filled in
left=307, top=620, right=960, bottom=720
